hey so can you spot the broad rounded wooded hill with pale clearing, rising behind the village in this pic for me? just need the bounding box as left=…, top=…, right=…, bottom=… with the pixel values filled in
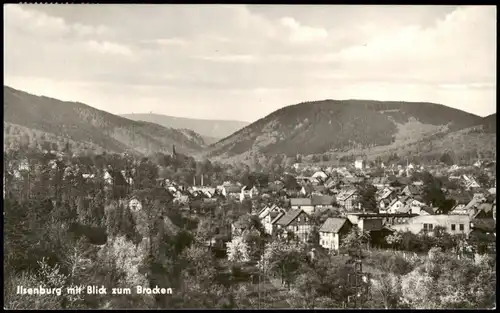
left=208, top=100, right=481, bottom=159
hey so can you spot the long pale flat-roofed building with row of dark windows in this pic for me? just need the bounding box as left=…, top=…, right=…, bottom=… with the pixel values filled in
left=392, top=214, right=471, bottom=236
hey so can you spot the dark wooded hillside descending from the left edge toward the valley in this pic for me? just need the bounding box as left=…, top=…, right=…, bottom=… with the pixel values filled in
left=4, top=86, right=205, bottom=155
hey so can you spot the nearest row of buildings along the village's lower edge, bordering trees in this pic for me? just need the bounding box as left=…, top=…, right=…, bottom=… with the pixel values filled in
left=252, top=202, right=496, bottom=250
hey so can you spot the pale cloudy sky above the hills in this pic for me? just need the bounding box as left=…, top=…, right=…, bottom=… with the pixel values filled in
left=4, top=4, right=497, bottom=122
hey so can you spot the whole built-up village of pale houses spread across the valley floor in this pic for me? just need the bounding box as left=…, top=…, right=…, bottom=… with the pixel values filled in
left=124, top=157, right=496, bottom=252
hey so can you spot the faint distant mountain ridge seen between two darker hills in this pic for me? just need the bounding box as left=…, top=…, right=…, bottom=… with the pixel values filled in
left=121, top=113, right=249, bottom=143
